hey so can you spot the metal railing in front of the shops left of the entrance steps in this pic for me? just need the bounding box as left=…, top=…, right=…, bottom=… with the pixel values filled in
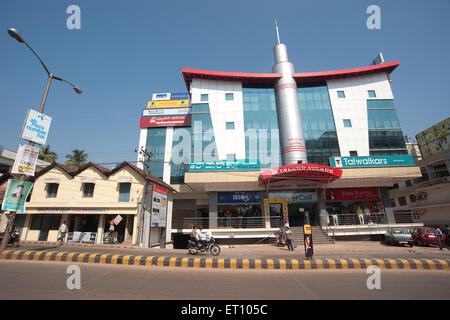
left=183, top=216, right=282, bottom=229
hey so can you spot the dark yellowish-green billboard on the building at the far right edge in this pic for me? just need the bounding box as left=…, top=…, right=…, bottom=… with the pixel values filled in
left=416, top=118, right=450, bottom=157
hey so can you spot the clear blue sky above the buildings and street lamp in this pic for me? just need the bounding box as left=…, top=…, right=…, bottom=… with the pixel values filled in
left=0, top=0, right=450, bottom=163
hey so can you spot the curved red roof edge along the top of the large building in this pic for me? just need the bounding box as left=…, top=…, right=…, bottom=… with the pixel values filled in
left=181, top=61, right=400, bottom=92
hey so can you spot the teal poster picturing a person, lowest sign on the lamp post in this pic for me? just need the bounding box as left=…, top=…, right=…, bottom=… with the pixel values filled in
left=2, top=179, right=33, bottom=213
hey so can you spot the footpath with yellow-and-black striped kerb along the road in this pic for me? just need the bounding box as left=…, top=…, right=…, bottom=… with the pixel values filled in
left=0, top=241, right=450, bottom=271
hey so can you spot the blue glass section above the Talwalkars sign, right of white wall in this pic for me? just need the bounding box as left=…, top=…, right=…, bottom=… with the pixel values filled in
left=367, top=99, right=408, bottom=156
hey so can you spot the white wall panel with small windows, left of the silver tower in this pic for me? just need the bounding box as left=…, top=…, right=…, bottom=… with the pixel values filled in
left=191, top=79, right=245, bottom=160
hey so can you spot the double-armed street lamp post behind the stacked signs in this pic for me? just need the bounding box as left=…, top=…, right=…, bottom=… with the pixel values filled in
left=0, top=28, right=82, bottom=252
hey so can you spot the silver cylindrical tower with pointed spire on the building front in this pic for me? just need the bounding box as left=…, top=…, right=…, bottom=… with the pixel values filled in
left=272, top=36, right=307, bottom=165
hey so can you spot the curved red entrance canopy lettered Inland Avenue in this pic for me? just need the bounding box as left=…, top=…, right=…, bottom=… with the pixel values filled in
left=259, top=163, right=342, bottom=185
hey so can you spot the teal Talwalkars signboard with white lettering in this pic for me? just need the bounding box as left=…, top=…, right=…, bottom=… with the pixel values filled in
left=330, top=155, right=415, bottom=168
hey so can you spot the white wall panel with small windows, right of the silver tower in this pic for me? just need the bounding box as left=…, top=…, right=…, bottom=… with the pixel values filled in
left=327, top=73, right=394, bottom=157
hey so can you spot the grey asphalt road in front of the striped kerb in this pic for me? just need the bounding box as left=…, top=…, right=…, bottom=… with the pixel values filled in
left=0, top=260, right=450, bottom=300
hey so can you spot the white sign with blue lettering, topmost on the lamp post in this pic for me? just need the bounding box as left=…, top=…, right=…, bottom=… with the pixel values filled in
left=21, top=109, right=52, bottom=144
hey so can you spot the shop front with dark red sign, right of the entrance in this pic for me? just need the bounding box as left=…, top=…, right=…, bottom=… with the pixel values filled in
left=325, top=187, right=387, bottom=226
